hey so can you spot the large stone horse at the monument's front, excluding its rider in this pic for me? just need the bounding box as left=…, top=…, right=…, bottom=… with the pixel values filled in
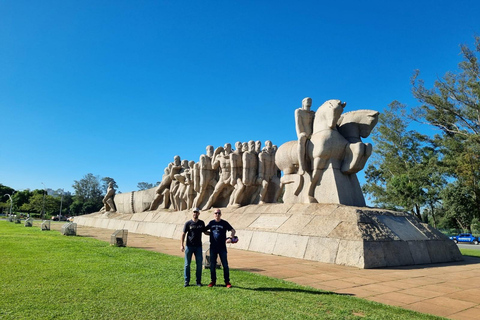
left=275, top=100, right=379, bottom=206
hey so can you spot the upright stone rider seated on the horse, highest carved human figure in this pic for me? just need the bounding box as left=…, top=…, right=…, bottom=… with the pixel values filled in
left=295, top=97, right=315, bottom=175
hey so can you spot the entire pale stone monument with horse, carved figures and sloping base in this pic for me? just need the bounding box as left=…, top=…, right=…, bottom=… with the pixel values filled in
left=75, top=98, right=462, bottom=268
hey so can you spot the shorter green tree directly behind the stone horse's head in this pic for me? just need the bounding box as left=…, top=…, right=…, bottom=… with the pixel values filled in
left=363, top=101, right=444, bottom=219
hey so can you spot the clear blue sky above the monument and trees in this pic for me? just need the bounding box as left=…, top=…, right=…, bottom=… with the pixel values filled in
left=0, top=0, right=480, bottom=192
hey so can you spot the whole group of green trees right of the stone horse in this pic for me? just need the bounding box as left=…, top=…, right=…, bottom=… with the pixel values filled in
left=363, top=36, right=480, bottom=231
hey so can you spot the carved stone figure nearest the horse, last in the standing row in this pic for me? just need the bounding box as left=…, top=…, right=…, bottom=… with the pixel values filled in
left=257, top=140, right=280, bottom=204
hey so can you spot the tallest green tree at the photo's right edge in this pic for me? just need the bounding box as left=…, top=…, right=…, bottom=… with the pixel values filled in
left=412, top=36, right=480, bottom=228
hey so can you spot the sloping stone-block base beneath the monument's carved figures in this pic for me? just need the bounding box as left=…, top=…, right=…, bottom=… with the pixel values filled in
left=75, top=203, right=463, bottom=268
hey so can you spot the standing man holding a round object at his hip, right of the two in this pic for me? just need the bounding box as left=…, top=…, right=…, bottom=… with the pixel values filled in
left=205, top=209, right=235, bottom=288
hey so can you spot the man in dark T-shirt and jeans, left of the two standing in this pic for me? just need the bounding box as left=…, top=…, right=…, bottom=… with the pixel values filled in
left=181, top=208, right=205, bottom=287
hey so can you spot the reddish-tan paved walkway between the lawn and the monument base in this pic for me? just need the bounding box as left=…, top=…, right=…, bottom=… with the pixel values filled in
left=52, top=225, right=480, bottom=320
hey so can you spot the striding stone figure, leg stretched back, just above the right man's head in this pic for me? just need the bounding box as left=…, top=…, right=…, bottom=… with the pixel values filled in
left=204, top=143, right=232, bottom=210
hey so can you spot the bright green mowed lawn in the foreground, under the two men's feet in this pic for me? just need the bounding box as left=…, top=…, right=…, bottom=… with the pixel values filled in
left=0, top=221, right=439, bottom=319
